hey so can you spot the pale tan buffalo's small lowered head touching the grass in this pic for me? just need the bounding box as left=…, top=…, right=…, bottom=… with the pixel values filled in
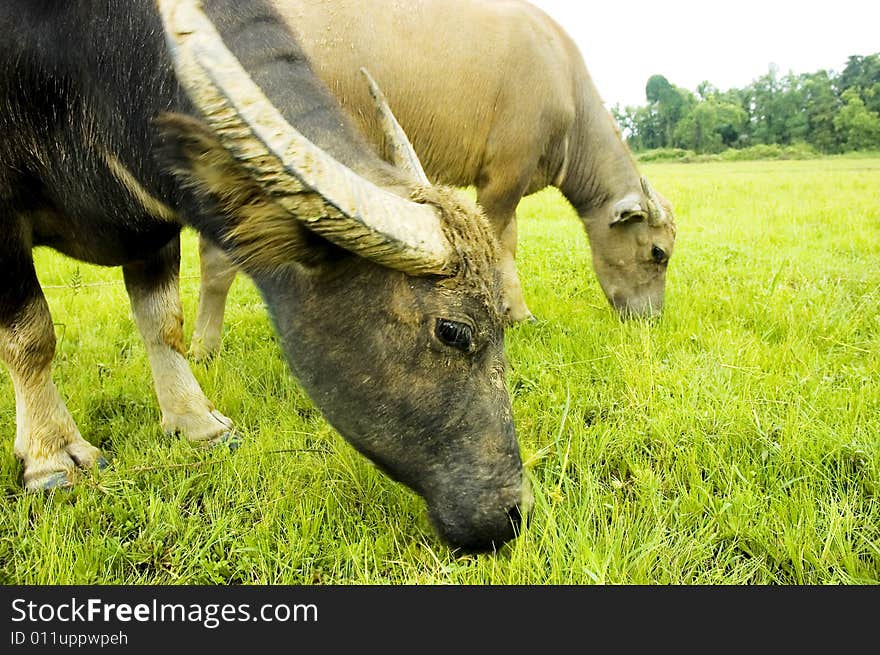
left=585, top=177, right=675, bottom=318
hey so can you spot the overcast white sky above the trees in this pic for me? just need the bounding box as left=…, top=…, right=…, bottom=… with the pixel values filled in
left=531, top=0, right=880, bottom=107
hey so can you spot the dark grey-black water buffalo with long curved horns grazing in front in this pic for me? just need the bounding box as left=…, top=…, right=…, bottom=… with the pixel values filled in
left=0, top=0, right=528, bottom=550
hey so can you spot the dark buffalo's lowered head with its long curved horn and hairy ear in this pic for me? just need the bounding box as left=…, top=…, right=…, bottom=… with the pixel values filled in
left=160, top=2, right=528, bottom=551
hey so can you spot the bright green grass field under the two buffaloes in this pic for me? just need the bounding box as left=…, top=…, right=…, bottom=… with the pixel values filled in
left=0, top=159, right=880, bottom=584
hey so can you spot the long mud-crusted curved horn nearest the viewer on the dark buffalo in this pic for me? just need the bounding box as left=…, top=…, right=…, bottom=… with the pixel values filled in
left=158, top=0, right=454, bottom=275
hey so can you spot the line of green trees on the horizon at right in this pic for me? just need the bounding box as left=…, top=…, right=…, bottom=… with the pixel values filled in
left=612, top=53, right=880, bottom=153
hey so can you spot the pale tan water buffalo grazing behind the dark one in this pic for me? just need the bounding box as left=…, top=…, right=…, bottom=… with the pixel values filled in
left=192, top=0, right=675, bottom=356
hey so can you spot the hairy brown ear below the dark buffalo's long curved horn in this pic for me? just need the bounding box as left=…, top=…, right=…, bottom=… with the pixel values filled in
left=156, top=113, right=343, bottom=274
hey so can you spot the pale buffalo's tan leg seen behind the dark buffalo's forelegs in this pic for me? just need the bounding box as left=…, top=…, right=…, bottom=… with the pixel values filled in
left=190, top=238, right=236, bottom=359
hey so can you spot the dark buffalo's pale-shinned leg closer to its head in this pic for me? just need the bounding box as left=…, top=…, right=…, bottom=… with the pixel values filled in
left=122, top=239, right=238, bottom=446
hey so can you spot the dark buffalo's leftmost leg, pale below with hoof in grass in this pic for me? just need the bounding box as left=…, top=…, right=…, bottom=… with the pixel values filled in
left=0, top=242, right=107, bottom=490
